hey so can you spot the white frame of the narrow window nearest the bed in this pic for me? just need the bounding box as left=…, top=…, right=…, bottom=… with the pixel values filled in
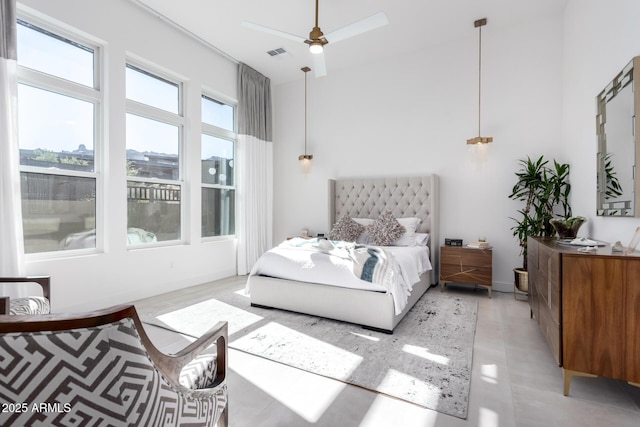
left=198, top=90, right=238, bottom=242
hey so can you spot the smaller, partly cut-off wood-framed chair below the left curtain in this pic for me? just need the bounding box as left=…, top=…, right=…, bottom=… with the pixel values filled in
left=0, top=276, right=51, bottom=314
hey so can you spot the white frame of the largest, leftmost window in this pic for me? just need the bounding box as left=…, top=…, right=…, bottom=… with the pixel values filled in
left=16, top=14, right=106, bottom=260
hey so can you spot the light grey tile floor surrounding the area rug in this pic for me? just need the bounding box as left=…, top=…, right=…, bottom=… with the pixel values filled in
left=135, top=277, right=640, bottom=427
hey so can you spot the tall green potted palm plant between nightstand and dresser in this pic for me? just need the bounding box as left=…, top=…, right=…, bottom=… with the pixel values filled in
left=509, top=156, right=571, bottom=292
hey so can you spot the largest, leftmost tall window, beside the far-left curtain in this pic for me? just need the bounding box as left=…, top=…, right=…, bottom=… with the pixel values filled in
left=17, top=20, right=102, bottom=254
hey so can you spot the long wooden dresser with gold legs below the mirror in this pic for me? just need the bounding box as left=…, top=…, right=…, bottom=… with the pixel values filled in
left=527, top=237, right=640, bottom=395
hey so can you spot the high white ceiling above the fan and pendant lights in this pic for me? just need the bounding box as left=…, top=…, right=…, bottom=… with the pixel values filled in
left=131, top=0, right=568, bottom=84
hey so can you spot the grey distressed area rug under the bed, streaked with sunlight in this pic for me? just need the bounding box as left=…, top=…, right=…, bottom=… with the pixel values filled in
left=142, top=290, right=477, bottom=418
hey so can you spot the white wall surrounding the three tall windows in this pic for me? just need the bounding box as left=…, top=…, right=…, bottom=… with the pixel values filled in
left=19, top=0, right=237, bottom=311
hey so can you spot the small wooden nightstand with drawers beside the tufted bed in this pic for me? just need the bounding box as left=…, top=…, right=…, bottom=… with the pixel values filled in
left=440, top=246, right=493, bottom=298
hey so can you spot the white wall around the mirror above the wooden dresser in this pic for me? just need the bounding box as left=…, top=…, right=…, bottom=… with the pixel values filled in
left=562, top=0, right=640, bottom=245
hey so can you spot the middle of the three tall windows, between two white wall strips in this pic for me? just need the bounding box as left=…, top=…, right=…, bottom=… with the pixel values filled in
left=126, top=64, right=183, bottom=245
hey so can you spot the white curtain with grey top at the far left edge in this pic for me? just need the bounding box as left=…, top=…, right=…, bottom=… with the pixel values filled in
left=0, top=0, right=24, bottom=277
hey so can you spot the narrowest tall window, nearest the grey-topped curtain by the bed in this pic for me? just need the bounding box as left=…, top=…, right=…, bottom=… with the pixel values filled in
left=201, top=96, right=236, bottom=237
